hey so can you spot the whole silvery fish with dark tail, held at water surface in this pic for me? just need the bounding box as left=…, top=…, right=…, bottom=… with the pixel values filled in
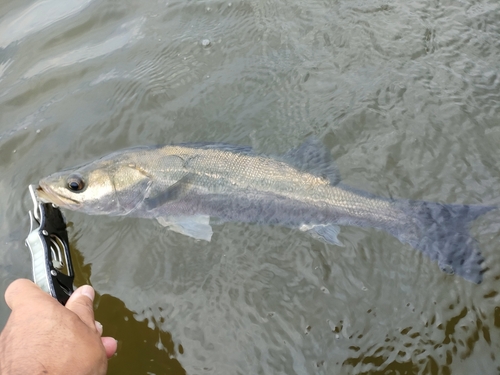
left=38, top=138, right=496, bottom=284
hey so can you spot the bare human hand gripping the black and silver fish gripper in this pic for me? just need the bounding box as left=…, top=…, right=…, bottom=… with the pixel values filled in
left=0, top=279, right=117, bottom=375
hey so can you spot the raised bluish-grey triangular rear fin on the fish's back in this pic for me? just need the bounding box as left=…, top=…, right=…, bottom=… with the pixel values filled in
left=283, top=137, right=340, bottom=185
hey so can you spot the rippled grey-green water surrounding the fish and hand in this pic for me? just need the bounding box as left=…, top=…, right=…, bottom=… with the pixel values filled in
left=0, top=0, right=500, bottom=374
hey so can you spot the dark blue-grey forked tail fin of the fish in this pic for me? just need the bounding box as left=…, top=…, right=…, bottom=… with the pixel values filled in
left=395, top=201, right=496, bottom=284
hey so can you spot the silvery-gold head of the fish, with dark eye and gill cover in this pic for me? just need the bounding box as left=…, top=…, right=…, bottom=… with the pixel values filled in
left=37, top=154, right=151, bottom=215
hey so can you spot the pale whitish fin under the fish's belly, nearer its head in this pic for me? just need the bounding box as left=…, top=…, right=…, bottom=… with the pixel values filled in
left=157, top=215, right=213, bottom=242
